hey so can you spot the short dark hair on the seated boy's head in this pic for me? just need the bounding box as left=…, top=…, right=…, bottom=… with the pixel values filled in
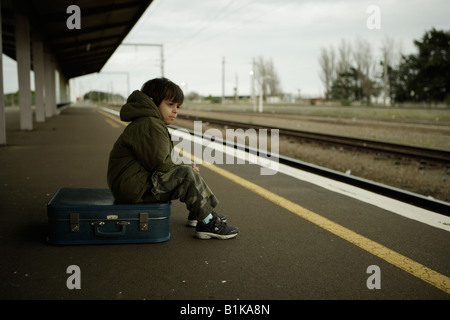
left=141, top=78, right=184, bottom=107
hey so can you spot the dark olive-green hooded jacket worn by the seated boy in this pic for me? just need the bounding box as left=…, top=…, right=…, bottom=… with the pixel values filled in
left=107, top=90, right=175, bottom=203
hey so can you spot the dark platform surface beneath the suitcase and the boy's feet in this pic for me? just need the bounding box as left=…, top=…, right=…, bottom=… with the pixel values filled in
left=0, top=106, right=450, bottom=304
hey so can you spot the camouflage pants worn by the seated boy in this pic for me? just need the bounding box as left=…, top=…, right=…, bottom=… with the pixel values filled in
left=143, top=165, right=219, bottom=221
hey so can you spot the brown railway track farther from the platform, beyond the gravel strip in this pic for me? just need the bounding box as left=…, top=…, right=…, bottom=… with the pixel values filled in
left=178, top=115, right=450, bottom=163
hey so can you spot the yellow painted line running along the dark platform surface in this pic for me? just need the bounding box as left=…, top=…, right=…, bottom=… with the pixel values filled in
left=96, top=109, right=450, bottom=294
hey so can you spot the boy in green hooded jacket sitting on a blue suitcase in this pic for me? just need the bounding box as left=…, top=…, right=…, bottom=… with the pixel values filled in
left=107, top=78, right=239, bottom=239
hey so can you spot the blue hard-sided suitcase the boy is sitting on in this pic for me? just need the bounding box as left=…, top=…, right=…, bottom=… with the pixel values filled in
left=47, top=188, right=171, bottom=245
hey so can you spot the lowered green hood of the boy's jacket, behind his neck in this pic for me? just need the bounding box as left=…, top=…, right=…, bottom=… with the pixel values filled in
left=120, top=90, right=162, bottom=121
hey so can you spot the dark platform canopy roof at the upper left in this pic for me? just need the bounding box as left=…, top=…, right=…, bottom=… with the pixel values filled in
left=1, top=0, right=152, bottom=79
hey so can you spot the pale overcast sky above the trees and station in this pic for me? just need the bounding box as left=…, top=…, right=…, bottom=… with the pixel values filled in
left=3, top=0, right=450, bottom=99
